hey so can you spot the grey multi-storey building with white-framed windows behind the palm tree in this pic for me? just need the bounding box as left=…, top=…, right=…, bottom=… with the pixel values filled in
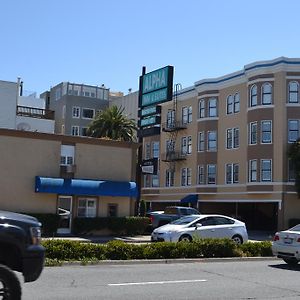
left=40, top=82, right=109, bottom=136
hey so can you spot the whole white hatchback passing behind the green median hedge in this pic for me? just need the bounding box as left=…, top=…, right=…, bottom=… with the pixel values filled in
left=151, top=215, right=248, bottom=244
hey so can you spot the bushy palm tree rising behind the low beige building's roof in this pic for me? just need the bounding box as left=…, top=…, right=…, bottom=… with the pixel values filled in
left=87, top=105, right=137, bottom=141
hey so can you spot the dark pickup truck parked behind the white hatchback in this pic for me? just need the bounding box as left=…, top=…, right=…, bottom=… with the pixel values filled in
left=150, top=206, right=200, bottom=228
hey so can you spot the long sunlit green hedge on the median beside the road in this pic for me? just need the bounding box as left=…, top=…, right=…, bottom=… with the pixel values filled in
left=42, top=239, right=272, bottom=264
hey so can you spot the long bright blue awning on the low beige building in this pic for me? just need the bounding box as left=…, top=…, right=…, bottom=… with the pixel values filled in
left=35, top=176, right=137, bottom=197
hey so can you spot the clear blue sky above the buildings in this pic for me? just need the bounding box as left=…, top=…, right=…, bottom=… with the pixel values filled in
left=0, top=0, right=300, bottom=94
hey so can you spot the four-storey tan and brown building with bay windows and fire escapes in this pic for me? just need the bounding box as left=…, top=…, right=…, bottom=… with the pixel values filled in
left=141, top=57, right=300, bottom=230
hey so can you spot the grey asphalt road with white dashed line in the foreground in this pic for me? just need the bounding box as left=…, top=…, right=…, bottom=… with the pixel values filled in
left=22, top=259, right=300, bottom=300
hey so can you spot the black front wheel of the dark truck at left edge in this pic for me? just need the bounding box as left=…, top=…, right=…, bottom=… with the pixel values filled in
left=0, top=265, right=21, bottom=300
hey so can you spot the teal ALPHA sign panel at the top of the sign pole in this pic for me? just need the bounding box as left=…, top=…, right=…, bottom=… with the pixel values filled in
left=139, top=66, right=174, bottom=108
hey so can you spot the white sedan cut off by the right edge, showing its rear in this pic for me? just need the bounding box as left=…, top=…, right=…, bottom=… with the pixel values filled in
left=272, top=224, right=300, bottom=265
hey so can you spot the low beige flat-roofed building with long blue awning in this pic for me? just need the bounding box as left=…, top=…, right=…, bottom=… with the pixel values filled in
left=0, top=129, right=137, bottom=233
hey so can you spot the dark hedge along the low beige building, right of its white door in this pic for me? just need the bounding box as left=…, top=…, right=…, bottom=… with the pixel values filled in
left=73, top=217, right=150, bottom=235
